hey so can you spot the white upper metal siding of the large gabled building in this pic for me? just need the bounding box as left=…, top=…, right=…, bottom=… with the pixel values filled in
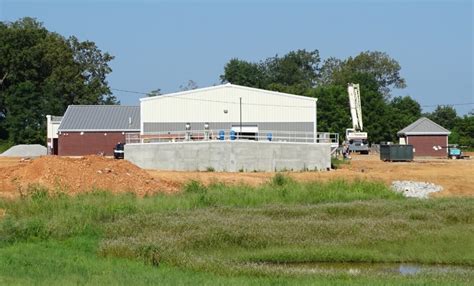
left=141, top=86, right=315, bottom=124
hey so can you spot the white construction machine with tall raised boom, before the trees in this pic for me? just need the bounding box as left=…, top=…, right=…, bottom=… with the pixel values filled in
left=346, top=83, right=369, bottom=154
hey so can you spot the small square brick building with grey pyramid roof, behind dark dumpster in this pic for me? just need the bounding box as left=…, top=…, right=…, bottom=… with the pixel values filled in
left=397, top=117, right=451, bottom=157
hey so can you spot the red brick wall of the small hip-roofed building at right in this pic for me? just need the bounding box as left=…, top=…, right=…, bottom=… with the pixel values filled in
left=406, top=135, right=448, bottom=157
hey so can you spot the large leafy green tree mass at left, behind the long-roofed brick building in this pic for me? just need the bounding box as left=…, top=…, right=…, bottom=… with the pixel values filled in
left=0, top=18, right=118, bottom=144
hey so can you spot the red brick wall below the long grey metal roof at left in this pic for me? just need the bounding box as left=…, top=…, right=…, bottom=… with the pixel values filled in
left=58, top=132, right=125, bottom=156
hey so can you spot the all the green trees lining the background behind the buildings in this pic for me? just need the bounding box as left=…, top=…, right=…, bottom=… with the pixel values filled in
left=0, top=18, right=474, bottom=146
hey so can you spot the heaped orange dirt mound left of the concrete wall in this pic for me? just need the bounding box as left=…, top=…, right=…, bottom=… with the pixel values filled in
left=0, top=156, right=178, bottom=198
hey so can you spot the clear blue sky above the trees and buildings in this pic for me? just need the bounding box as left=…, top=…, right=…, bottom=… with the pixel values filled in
left=0, top=0, right=474, bottom=115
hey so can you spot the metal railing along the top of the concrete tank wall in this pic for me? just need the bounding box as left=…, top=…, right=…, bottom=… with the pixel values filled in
left=125, top=130, right=339, bottom=148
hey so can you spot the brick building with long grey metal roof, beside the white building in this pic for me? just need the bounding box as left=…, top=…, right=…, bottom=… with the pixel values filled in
left=57, top=105, right=140, bottom=156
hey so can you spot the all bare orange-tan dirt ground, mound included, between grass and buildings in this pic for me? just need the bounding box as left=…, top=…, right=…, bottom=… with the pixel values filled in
left=0, top=153, right=474, bottom=197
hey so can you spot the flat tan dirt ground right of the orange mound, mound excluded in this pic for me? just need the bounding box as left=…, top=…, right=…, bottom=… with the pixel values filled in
left=148, top=154, right=474, bottom=196
